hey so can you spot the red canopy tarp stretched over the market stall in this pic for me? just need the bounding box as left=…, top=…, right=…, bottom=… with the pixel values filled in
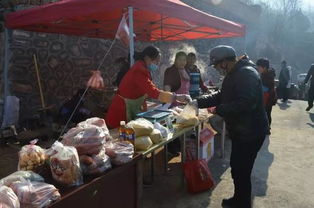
left=5, top=0, right=245, bottom=41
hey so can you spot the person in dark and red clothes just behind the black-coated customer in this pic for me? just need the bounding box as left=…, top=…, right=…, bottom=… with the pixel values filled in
left=256, top=58, right=277, bottom=133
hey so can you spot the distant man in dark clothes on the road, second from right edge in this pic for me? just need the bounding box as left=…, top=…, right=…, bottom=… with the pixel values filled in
left=278, top=61, right=291, bottom=102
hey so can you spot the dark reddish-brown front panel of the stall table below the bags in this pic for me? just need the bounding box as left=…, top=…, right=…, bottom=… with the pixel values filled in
left=50, top=155, right=143, bottom=208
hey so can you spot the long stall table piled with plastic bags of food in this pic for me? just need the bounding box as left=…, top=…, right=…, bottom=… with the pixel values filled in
left=0, top=106, right=215, bottom=208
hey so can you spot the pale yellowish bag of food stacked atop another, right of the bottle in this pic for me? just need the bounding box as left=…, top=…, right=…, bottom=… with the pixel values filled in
left=126, top=118, right=154, bottom=137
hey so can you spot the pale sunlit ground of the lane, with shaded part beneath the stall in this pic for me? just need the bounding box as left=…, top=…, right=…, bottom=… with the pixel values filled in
left=143, top=101, right=314, bottom=208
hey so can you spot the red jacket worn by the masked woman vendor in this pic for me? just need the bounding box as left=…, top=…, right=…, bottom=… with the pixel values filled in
left=105, top=61, right=160, bottom=128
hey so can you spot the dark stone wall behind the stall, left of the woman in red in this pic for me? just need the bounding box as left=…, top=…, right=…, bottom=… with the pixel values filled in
left=9, top=30, right=127, bottom=120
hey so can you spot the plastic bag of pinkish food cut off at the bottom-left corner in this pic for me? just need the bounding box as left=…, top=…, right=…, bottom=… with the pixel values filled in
left=0, top=185, right=20, bottom=208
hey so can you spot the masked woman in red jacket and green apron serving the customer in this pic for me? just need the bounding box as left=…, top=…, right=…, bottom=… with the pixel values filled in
left=105, top=46, right=191, bottom=128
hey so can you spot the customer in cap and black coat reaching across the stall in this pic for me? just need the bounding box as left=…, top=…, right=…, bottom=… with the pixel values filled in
left=192, top=45, right=268, bottom=208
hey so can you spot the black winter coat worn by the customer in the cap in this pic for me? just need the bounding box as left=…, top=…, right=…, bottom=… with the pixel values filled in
left=197, top=59, right=268, bottom=141
